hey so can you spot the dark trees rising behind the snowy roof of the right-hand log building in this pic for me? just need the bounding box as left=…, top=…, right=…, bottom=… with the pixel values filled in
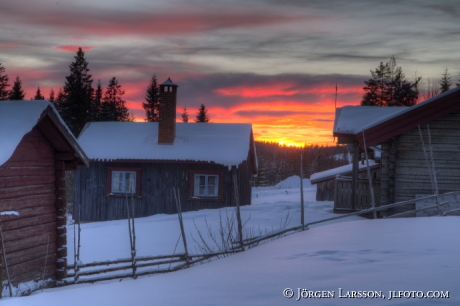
left=361, top=56, right=460, bottom=106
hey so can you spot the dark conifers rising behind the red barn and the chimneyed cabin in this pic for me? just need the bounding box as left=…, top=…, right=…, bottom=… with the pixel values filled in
left=0, top=48, right=210, bottom=137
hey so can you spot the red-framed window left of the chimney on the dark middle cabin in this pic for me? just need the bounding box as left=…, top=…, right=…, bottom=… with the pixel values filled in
left=107, top=167, right=141, bottom=197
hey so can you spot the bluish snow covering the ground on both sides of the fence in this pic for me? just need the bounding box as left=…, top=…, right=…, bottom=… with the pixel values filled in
left=1, top=177, right=460, bottom=306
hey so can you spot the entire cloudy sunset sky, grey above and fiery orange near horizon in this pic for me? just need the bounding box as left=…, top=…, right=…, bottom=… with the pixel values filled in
left=0, top=0, right=460, bottom=145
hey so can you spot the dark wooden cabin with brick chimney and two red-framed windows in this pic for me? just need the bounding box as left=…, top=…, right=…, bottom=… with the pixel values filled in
left=73, top=79, right=257, bottom=221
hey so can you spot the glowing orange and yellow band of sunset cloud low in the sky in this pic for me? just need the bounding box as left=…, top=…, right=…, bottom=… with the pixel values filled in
left=121, top=82, right=362, bottom=146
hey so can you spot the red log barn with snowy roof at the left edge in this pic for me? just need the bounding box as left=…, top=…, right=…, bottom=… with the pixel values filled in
left=0, top=101, right=88, bottom=294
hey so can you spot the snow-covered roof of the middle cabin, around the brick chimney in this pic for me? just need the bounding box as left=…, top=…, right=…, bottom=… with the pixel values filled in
left=78, top=122, right=252, bottom=167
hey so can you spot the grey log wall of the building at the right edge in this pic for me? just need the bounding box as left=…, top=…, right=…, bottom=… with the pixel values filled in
left=382, top=111, right=460, bottom=212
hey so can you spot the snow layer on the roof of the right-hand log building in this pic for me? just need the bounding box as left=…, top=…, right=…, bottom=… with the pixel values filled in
left=334, top=106, right=410, bottom=135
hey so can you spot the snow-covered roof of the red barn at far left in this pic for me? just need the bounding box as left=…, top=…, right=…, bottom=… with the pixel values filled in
left=0, top=100, right=82, bottom=165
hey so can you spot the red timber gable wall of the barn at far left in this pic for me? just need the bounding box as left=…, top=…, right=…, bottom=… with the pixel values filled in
left=0, top=127, right=58, bottom=286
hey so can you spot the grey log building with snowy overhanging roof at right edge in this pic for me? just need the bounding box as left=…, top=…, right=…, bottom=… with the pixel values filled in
left=334, top=87, right=460, bottom=215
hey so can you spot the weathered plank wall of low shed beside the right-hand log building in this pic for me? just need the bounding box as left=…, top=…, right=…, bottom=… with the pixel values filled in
left=334, top=177, right=380, bottom=212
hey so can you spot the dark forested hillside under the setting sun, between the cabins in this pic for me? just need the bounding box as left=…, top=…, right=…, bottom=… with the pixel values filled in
left=255, top=141, right=349, bottom=186
